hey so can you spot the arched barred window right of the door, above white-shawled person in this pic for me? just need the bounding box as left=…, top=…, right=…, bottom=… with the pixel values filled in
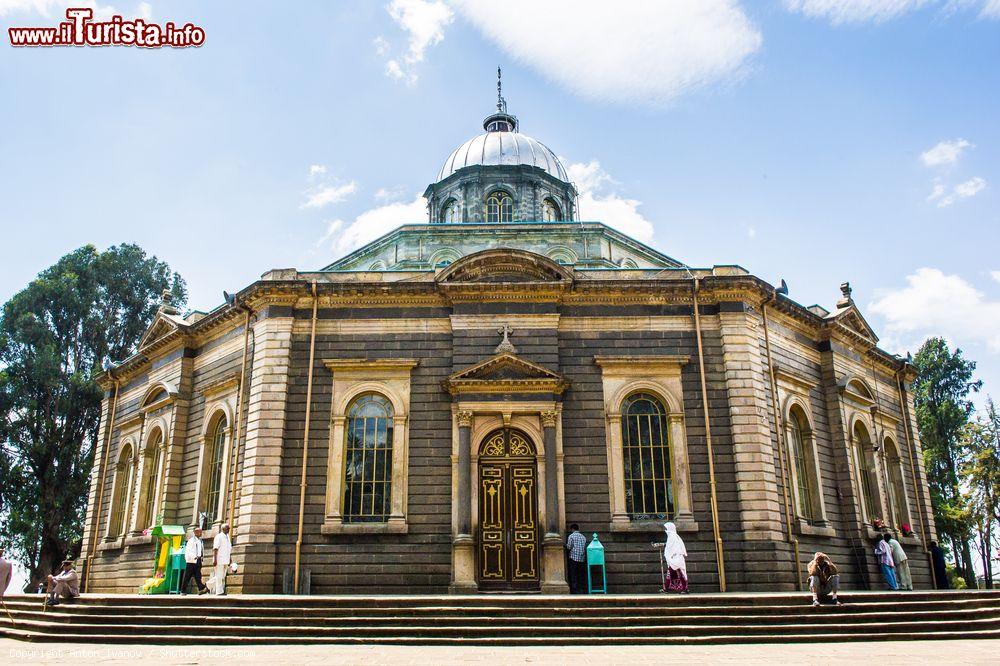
left=621, top=393, right=674, bottom=520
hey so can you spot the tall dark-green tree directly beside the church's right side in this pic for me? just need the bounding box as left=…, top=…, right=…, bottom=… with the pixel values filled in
left=913, top=338, right=982, bottom=586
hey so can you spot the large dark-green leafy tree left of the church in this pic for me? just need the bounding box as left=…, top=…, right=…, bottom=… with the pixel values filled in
left=0, top=245, right=186, bottom=586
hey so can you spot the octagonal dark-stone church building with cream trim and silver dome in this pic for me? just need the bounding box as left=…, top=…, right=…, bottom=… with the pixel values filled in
left=81, top=91, right=935, bottom=594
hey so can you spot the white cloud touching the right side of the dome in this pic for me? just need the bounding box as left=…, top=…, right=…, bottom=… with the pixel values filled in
left=563, top=160, right=653, bottom=243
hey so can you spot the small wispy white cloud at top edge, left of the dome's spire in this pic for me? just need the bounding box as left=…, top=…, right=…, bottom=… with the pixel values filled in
left=374, top=0, right=455, bottom=85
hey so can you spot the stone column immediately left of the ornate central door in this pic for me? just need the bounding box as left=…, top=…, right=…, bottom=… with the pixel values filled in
left=448, top=411, right=479, bottom=594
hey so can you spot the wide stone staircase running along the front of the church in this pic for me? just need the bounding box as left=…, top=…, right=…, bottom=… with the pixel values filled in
left=0, top=592, right=1000, bottom=646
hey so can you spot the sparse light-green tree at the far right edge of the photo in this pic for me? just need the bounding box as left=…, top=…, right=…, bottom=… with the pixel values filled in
left=959, top=399, right=1000, bottom=589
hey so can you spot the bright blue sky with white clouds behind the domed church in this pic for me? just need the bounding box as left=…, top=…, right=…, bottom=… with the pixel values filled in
left=0, top=0, right=1000, bottom=404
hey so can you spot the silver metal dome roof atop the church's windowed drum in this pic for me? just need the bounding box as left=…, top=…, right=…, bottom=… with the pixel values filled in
left=437, top=131, right=569, bottom=182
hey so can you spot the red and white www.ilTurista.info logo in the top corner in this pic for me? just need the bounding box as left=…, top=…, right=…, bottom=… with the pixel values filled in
left=7, top=7, right=205, bottom=49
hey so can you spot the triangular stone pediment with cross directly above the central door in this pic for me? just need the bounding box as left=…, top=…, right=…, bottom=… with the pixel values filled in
left=444, top=353, right=568, bottom=393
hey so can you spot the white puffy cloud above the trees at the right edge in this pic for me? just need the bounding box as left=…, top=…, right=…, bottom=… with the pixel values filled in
left=869, top=268, right=1000, bottom=353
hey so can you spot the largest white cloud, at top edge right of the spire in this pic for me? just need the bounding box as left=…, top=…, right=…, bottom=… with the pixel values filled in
left=452, top=0, right=762, bottom=105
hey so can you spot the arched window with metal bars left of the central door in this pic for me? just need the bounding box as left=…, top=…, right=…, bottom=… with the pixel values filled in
left=343, top=393, right=393, bottom=523
